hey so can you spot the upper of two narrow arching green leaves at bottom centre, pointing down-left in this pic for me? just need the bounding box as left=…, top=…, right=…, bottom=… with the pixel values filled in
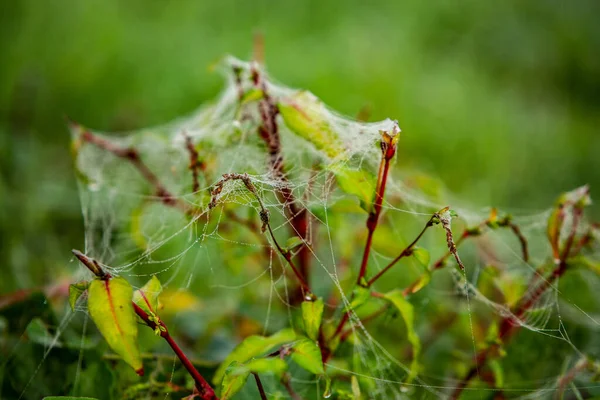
left=213, top=328, right=296, bottom=385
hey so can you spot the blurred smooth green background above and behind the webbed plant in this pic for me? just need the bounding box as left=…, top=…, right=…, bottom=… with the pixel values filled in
left=0, top=0, right=600, bottom=293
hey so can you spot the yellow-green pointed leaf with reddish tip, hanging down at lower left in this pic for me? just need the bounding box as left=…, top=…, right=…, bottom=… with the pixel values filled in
left=88, top=277, right=144, bottom=375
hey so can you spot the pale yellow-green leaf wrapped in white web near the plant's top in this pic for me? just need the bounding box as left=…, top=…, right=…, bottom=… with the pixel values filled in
left=277, top=91, right=346, bottom=159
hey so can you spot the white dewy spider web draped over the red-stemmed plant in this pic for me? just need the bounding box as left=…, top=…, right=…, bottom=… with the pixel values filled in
left=14, top=54, right=600, bottom=399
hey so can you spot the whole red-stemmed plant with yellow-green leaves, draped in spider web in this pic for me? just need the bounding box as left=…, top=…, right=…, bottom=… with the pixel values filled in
left=30, top=59, right=600, bottom=399
